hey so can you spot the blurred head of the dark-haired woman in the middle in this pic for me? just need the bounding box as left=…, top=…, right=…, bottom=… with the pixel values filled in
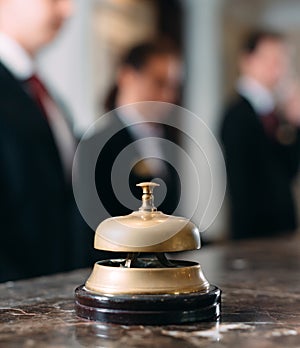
left=104, top=41, right=182, bottom=111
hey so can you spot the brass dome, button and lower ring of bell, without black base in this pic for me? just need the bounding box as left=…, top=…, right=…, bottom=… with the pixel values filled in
left=85, top=182, right=209, bottom=296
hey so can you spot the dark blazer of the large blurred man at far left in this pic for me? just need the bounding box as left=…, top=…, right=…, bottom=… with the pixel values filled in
left=0, top=62, right=90, bottom=281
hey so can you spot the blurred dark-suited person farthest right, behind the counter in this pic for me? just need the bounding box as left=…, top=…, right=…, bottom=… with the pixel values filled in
left=221, top=31, right=300, bottom=239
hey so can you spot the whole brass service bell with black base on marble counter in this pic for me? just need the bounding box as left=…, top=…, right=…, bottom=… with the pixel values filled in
left=75, top=182, right=221, bottom=325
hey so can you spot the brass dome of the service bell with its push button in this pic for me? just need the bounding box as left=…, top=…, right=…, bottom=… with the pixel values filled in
left=94, top=182, right=201, bottom=252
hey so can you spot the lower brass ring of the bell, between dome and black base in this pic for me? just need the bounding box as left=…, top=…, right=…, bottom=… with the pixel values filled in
left=85, top=259, right=209, bottom=295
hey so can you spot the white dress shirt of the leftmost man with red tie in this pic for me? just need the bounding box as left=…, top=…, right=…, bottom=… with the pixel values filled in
left=0, top=33, right=75, bottom=178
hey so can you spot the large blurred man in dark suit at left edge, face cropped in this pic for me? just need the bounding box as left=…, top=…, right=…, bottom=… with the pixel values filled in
left=0, top=0, right=90, bottom=281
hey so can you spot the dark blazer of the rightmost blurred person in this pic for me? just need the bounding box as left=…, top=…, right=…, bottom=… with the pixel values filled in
left=221, top=96, right=300, bottom=239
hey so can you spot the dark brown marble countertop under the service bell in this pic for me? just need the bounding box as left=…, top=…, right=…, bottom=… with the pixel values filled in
left=0, top=238, right=300, bottom=348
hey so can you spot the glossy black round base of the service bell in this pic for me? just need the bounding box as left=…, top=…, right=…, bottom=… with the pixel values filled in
left=75, top=285, right=221, bottom=325
